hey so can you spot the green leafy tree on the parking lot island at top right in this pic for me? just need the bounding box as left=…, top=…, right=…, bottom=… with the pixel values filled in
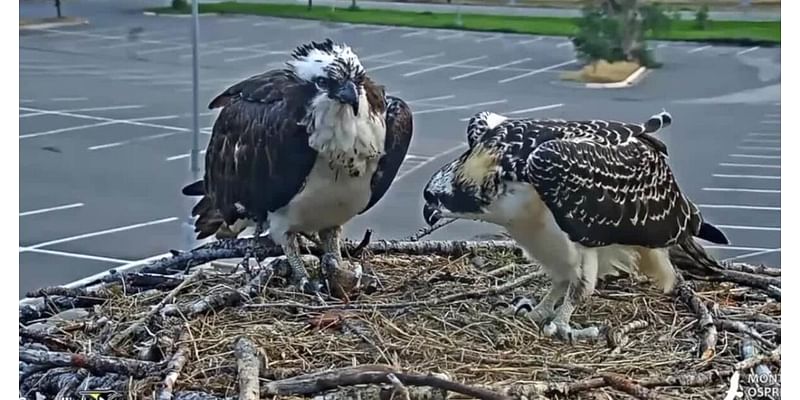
left=572, top=0, right=671, bottom=67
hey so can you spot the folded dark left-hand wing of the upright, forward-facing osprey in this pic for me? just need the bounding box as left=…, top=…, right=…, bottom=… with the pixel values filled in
left=190, top=70, right=316, bottom=236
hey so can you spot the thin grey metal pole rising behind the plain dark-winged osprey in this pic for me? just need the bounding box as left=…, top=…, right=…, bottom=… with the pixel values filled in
left=184, top=0, right=201, bottom=250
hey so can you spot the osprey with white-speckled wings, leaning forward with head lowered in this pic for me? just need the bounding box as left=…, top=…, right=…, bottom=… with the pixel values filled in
left=423, top=112, right=728, bottom=338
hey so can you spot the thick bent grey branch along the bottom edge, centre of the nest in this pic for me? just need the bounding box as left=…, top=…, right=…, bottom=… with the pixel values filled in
left=262, top=364, right=511, bottom=400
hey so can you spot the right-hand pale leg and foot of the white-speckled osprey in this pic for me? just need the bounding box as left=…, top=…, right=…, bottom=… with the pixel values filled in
left=544, top=249, right=600, bottom=342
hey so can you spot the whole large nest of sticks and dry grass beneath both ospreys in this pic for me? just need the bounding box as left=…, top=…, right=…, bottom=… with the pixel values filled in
left=19, top=234, right=781, bottom=400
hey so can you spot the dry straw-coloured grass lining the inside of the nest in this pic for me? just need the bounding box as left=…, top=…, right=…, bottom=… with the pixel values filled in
left=20, top=247, right=781, bottom=399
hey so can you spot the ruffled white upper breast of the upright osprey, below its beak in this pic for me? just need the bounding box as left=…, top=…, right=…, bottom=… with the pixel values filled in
left=308, top=93, right=386, bottom=176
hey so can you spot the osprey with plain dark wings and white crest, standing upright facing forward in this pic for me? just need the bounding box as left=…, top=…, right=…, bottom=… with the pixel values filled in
left=183, top=39, right=413, bottom=287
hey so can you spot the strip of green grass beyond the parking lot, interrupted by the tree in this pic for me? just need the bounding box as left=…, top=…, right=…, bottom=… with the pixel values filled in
left=149, top=2, right=781, bottom=45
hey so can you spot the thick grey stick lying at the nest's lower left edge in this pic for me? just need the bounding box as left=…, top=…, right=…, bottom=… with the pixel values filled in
left=19, top=347, right=161, bottom=378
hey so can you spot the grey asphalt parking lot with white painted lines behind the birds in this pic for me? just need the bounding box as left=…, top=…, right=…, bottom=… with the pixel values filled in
left=20, top=7, right=781, bottom=293
